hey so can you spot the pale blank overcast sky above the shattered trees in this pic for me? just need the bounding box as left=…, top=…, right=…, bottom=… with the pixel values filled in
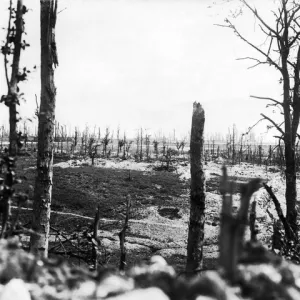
left=0, top=0, right=280, bottom=139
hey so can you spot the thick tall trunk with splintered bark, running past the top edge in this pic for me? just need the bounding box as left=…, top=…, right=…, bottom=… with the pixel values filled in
left=30, top=0, right=58, bottom=257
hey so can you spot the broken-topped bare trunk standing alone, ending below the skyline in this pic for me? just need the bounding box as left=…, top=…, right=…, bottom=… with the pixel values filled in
left=186, top=102, right=205, bottom=276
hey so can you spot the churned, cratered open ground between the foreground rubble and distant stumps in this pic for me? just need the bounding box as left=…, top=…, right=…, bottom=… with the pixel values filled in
left=11, top=156, right=298, bottom=272
